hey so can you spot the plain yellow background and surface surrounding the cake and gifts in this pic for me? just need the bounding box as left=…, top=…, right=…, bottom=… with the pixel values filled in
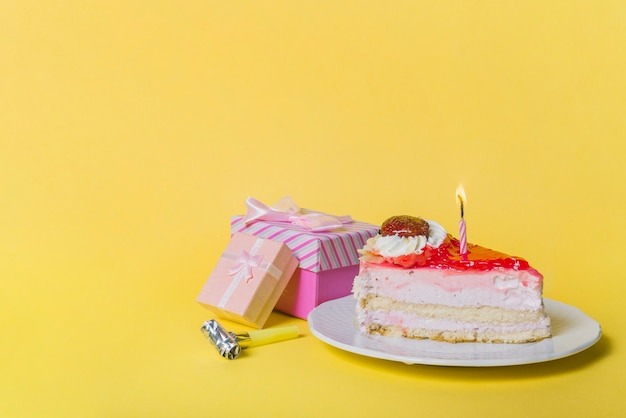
left=0, top=0, right=626, bottom=417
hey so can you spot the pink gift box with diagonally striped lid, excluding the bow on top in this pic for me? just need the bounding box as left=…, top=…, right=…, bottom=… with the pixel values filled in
left=231, top=216, right=380, bottom=319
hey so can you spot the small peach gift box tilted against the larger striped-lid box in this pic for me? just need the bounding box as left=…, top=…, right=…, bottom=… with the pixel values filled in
left=197, top=233, right=298, bottom=328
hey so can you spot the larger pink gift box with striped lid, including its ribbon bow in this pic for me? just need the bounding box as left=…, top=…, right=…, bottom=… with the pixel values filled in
left=231, top=199, right=379, bottom=319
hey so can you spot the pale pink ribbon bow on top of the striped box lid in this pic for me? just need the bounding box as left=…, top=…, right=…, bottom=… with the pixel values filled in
left=243, top=196, right=352, bottom=232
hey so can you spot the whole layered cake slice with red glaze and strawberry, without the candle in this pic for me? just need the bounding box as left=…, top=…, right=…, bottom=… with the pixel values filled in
left=353, top=216, right=550, bottom=343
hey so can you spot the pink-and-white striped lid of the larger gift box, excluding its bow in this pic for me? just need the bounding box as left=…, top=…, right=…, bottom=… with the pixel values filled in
left=230, top=216, right=379, bottom=273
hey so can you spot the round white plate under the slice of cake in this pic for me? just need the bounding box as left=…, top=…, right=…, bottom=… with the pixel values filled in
left=308, top=296, right=602, bottom=367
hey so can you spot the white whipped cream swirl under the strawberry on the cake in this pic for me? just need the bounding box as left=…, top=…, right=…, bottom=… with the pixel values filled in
left=359, top=220, right=448, bottom=262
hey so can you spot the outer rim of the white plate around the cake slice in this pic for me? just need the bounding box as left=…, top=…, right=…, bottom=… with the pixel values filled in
left=307, top=295, right=602, bottom=367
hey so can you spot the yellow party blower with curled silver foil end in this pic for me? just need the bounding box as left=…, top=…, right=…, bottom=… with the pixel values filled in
left=200, top=319, right=300, bottom=360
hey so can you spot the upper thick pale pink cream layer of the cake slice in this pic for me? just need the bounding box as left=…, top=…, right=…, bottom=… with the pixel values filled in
left=353, top=263, right=543, bottom=310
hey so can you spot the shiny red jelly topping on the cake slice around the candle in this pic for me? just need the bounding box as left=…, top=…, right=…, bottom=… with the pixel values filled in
left=387, top=235, right=533, bottom=271
